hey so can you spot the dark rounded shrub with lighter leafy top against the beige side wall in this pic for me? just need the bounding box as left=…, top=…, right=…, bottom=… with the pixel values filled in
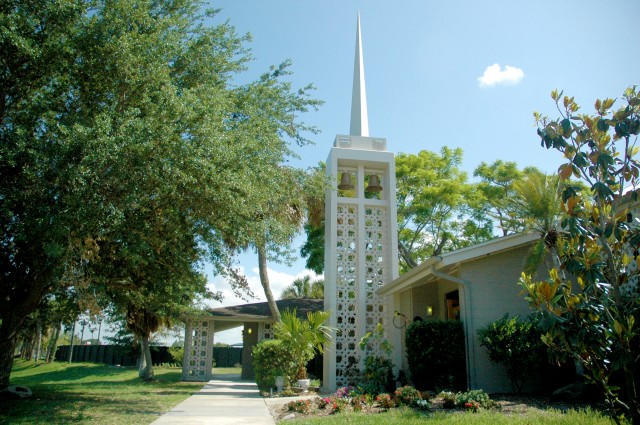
left=478, top=314, right=547, bottom=393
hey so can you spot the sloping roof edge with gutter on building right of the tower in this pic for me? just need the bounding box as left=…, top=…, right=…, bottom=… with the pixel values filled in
left=378, top=233, right=540, bottom=295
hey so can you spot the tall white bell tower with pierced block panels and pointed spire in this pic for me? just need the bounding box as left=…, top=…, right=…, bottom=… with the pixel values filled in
left=323, top=14, right=398, bottom=390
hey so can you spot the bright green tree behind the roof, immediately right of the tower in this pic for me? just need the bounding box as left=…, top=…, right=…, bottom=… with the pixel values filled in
left=396, top=147, right=493, bottom=270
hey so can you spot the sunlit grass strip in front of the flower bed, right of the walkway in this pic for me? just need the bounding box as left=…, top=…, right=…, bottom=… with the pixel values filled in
left=286, top=409, right=615, bottom=425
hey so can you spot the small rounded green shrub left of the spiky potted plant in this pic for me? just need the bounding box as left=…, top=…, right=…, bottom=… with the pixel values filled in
left=252, top=339, right=296, bottom=391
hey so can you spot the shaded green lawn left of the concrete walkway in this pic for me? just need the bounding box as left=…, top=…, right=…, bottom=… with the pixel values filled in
left=0, top=360, right=240, bottom=424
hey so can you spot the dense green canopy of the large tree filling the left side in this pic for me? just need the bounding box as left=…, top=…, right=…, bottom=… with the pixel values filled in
left=0, top=0, right=318, bottom=387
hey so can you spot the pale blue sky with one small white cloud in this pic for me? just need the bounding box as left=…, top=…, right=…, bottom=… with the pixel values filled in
left=204, top=0, right=640, bottom=343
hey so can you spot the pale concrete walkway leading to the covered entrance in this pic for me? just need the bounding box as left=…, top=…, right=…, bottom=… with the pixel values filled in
left=153, top=375, right=275, bottom=425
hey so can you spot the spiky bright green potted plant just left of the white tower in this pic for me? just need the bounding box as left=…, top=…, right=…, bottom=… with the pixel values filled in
left=275, top=309, right=331, bottom=391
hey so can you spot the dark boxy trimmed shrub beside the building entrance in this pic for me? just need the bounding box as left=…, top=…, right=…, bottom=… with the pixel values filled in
left=405, top=320, right=467, bottom=390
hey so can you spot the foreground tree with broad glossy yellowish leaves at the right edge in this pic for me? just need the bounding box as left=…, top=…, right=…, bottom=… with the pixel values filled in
left=521, top=87, right=640, bottom=424
